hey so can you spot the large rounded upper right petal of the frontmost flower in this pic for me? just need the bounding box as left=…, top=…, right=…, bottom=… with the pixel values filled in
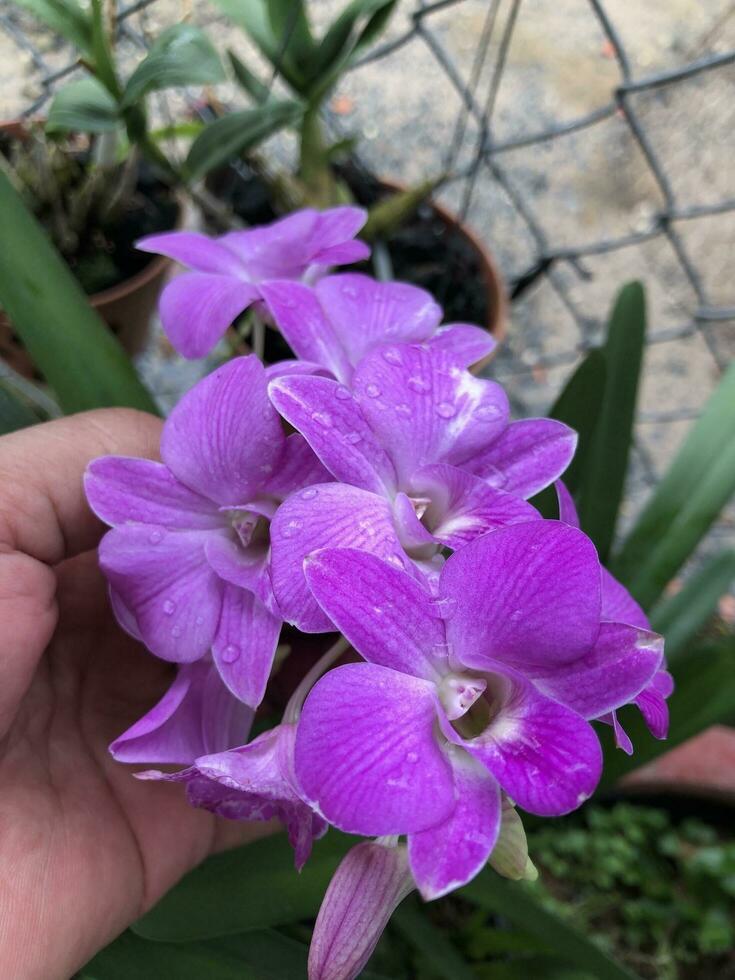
left=440, top=521, right=601, bottom=672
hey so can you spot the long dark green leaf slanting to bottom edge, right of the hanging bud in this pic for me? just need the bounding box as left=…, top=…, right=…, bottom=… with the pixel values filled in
left=461, top=870, right=634, bottom=980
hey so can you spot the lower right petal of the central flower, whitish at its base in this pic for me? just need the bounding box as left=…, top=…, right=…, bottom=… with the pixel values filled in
left=411, top=464, right=541, bottom=548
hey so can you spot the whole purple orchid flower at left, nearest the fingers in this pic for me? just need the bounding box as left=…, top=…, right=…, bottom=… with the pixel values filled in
left=85, top=356, right=326, bottom=707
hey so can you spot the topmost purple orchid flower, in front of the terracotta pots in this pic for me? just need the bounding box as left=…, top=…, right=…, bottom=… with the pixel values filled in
left=137, top=207, right=370, bottom=358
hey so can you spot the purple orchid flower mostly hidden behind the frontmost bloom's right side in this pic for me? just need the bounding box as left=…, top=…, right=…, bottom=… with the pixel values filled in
left=556, top=480, right=674, bottom=755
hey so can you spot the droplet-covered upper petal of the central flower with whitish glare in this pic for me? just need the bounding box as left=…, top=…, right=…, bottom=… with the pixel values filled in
left=353, top=344, right=508, bottom=487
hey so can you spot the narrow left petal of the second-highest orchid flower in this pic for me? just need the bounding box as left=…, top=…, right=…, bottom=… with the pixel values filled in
left=261, top=279, right=350, bottom=380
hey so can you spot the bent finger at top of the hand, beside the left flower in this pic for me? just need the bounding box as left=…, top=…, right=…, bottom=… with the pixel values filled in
left=0, top=408, right=161, bottom=565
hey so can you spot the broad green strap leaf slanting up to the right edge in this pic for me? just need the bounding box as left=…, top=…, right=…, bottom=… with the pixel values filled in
left=611, top=363, right=735, bottom=584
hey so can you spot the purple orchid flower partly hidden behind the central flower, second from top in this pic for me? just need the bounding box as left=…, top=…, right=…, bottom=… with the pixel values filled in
left=261, top=273, right=495, bottom=385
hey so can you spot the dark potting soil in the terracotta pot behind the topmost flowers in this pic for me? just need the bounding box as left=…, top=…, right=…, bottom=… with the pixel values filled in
left=211, top=163, right=490, bottom=360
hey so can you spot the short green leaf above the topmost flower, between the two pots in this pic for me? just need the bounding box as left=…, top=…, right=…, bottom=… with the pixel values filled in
left=186, top=99, right=303, bottom=177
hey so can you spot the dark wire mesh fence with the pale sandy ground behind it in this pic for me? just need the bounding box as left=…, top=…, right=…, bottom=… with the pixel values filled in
left=0, top=0, right=735, bottom=568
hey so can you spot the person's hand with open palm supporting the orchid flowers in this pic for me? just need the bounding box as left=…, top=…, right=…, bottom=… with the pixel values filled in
left=0, top=409, right=262, bottom=980
